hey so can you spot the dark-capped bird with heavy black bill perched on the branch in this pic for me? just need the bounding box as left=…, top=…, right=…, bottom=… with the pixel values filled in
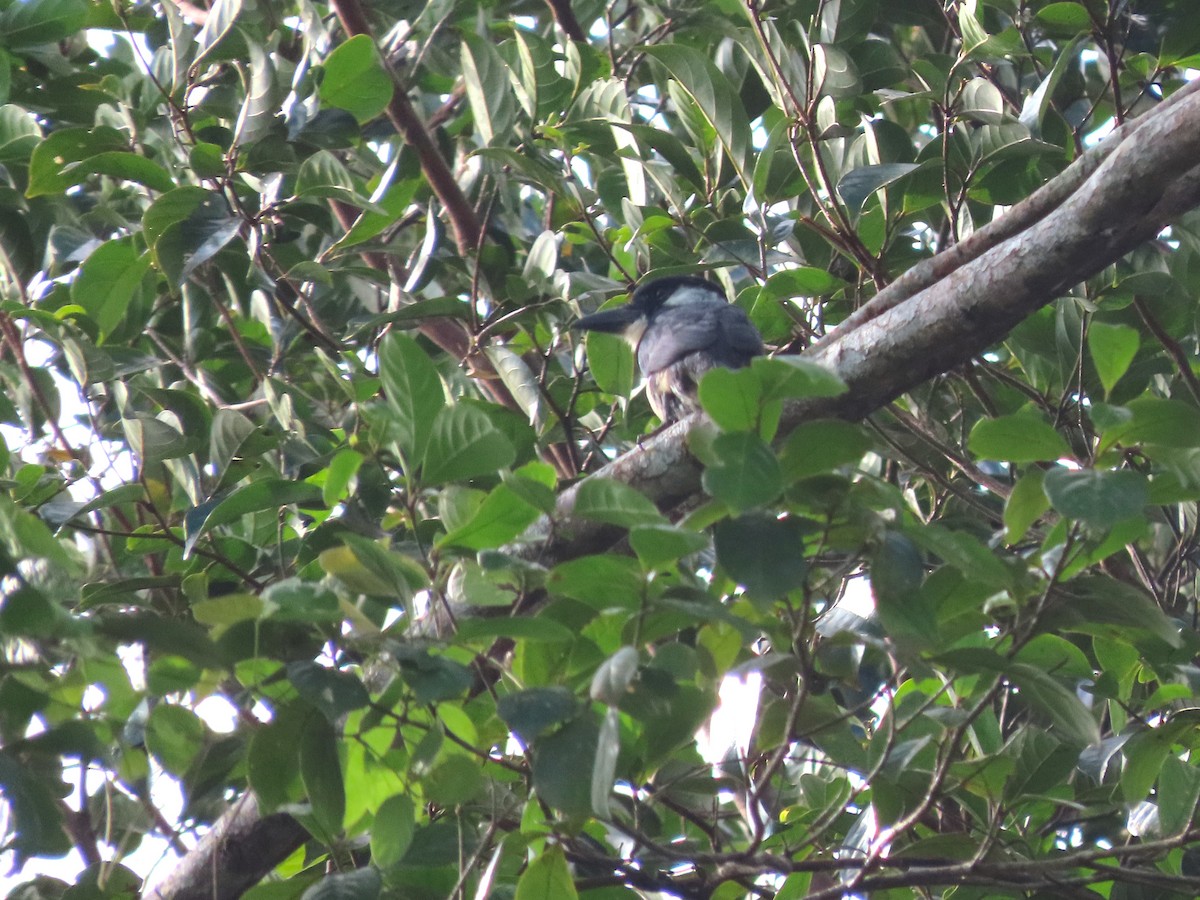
left=574, top=275, right=763, bottom=426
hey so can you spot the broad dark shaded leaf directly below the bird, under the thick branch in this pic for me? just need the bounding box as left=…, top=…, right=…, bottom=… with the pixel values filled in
left=713, top=514, right=809, bottom=601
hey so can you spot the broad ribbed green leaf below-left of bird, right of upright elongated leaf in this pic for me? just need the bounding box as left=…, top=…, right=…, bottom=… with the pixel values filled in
left=421, top=403, right=516, bottom=485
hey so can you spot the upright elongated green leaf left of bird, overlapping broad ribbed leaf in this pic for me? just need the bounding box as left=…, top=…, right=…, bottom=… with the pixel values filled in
left=379, top=331, right=445, bottom=463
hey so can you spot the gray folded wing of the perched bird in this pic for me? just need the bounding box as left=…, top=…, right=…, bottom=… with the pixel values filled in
left=637, top=301, right=762, bottom=374
